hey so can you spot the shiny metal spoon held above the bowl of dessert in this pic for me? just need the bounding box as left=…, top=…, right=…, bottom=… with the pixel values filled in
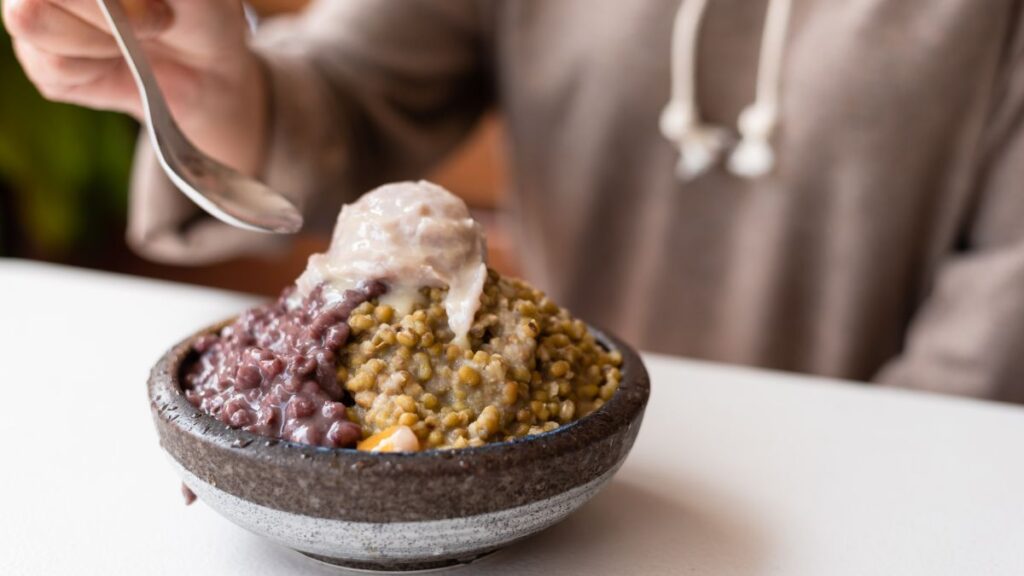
left=97, top=0, right=302, bottom=234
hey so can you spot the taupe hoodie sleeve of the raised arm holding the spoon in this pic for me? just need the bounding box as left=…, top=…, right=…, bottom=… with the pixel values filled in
left=128, top=0, right=493, bottom=263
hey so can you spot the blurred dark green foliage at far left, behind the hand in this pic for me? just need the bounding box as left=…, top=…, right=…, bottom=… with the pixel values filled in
left=0, top=20, right=138, bottom=260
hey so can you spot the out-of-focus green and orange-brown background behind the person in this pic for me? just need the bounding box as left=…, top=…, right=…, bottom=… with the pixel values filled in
left=0, top=0, right=518, bottom=295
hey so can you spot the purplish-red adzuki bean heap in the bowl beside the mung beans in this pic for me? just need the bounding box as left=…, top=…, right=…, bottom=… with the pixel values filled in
left=183, top=282, right=384, bottom=447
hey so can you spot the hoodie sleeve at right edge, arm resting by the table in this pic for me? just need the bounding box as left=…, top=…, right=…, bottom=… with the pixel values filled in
left=876, top=24, right=1024, bottom=402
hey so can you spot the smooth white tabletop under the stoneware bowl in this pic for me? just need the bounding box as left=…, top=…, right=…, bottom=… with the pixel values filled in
left=0, top=260, right=1024, bottom=576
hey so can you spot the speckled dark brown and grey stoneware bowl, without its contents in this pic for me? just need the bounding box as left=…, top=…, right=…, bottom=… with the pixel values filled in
left=148, top=317, right=650, bottom=571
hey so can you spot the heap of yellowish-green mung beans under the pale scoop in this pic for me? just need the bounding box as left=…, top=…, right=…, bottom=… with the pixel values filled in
left=338, top=271, right=622, bottom=449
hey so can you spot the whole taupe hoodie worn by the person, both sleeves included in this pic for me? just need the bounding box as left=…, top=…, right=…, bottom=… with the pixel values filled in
left=129, top=0, right=1024, bottom=401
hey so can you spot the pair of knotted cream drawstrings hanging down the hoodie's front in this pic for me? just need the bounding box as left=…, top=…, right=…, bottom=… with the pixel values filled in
left=659, top=0, right=792, bottom=180
